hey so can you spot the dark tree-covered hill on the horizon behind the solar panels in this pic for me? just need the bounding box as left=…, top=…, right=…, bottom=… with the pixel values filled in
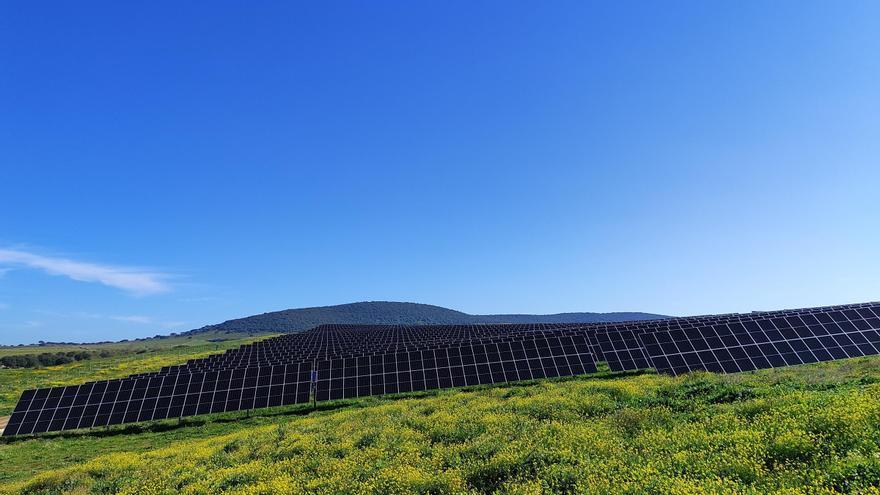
left=187, top=301, right=666, bottom=334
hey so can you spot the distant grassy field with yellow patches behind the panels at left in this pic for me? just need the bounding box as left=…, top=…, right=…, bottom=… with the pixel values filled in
left=0, top=333, right=267, bottom=416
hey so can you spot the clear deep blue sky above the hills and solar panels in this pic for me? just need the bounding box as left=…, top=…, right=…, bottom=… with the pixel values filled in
left=0, top=1, right=880, bottom=344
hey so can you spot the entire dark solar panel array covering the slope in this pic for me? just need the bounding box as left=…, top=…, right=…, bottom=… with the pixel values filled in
left=3, top=303, right=880, bottom=436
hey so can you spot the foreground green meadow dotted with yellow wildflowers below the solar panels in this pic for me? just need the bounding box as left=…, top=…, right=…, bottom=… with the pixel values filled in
left=0, top=358, right=880, bottom=494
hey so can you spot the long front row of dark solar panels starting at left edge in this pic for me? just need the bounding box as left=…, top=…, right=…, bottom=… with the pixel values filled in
left=4, top=337, right=596, bottom=435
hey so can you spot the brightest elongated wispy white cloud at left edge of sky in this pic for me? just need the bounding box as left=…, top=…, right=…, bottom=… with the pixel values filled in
left=0, top=249, right=171, bottom=296
